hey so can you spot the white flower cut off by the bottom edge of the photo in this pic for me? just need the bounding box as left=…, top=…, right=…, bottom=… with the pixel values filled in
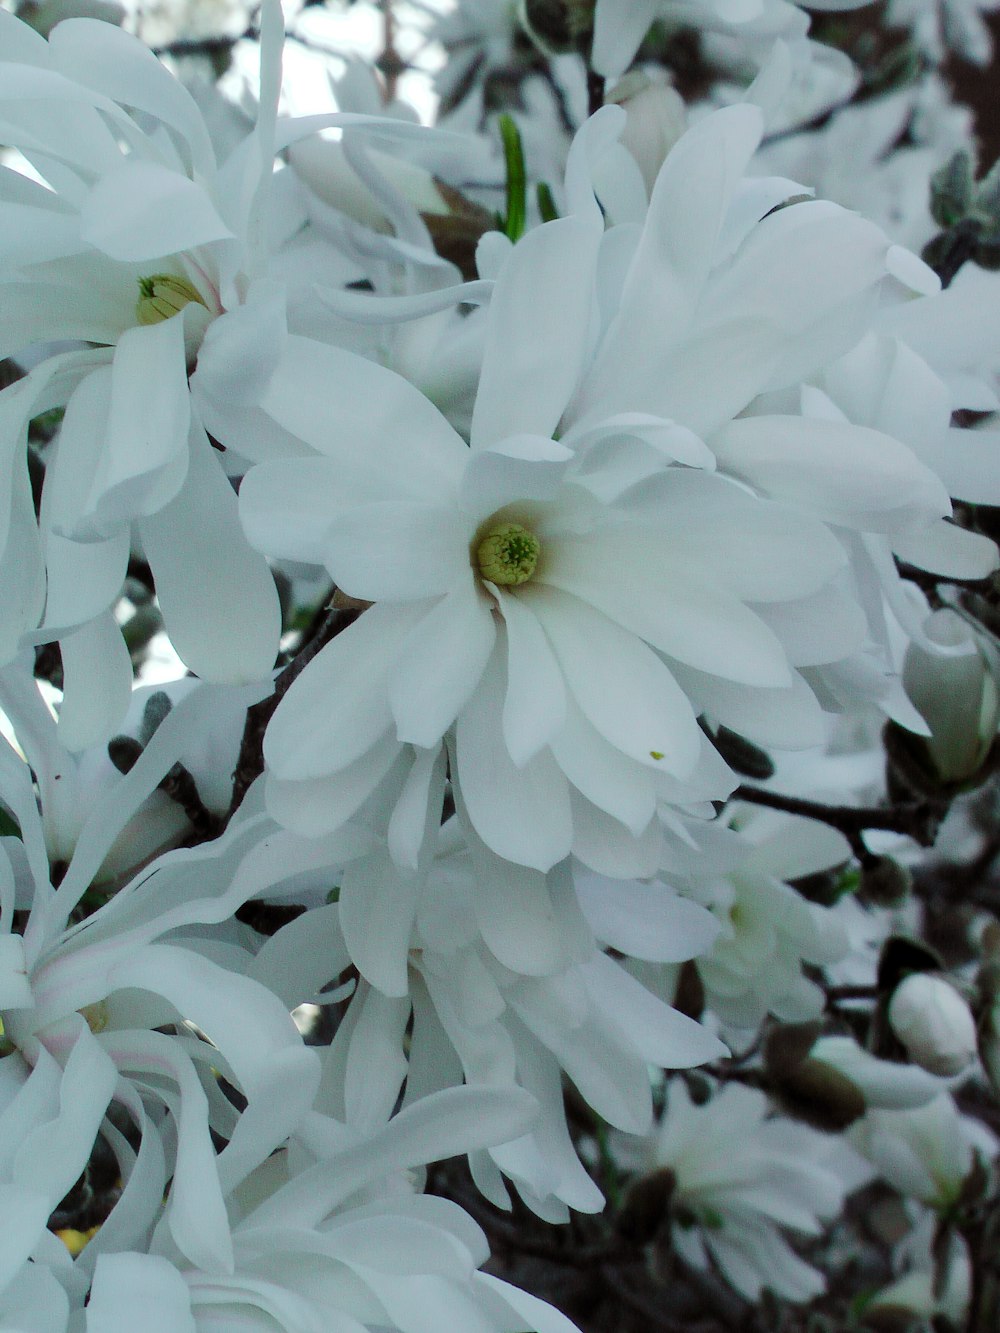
left=85, top=1090, right=576, bottom=1333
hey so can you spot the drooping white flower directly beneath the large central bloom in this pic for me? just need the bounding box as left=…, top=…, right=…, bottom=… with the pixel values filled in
left=241, top=820, right=727, bottom=1221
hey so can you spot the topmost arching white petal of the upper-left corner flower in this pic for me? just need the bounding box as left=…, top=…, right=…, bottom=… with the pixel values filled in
left=49, top=19, right=215, bottom=175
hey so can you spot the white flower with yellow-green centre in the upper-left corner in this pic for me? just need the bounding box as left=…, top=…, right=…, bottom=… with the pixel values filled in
left=0, top=3, right=434, bottom=748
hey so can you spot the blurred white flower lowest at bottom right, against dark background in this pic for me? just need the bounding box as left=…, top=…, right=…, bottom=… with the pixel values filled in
left=649, top=1080, right=845, bottom=1301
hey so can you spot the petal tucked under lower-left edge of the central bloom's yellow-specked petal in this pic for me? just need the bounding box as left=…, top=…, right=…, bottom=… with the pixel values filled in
left=551, top=696, right=656, bottom=837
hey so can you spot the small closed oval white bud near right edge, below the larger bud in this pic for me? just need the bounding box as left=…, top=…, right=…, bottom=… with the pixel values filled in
left=888, top=972, right=976, bottom=1078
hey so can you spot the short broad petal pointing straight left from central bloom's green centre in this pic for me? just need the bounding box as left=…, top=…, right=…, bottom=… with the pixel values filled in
left=323, top=500, right=469, bottom=601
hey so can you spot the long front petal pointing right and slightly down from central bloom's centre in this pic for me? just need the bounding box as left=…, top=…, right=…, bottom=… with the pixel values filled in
left=544, top=528, right=789, bottom=682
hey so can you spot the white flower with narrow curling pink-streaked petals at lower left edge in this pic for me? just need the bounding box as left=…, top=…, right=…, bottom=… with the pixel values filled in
left=0, top=686, right=319, bottom=1276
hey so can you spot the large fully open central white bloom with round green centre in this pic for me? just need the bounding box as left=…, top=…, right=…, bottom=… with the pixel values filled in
left=240, top=107, right=948, bottom=876
